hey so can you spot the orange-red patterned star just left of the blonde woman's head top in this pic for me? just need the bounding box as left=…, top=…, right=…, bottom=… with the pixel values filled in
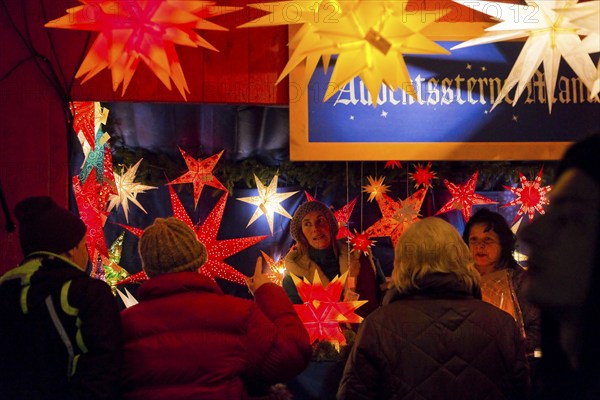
left=365, top=189, right=427, bottom=247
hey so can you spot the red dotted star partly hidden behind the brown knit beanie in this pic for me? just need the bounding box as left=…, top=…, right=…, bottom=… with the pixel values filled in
left=119, top=186, right=267, bottom=285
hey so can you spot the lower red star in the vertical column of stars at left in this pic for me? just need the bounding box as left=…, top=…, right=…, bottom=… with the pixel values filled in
left=73, top=169, right=109, bottom=260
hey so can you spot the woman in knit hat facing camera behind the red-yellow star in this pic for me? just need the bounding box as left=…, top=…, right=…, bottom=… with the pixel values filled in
left=282, top=200, right=385, bottom=317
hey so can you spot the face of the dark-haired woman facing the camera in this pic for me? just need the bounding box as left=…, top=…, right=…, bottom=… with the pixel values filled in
left=469, top=224, right=502, bottom=275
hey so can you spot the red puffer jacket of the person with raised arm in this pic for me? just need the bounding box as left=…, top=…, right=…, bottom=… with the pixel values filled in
left=121, top=272, right=311, bottom=400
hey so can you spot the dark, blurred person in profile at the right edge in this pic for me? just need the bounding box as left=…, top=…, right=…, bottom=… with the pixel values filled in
left=519, top=134, right=600, bottom=399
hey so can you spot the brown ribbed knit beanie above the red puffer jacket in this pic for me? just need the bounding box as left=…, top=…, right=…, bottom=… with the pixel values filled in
left=138, top=217, right=207, bottom=278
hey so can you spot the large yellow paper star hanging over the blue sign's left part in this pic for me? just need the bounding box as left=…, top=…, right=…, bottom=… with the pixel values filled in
left=242, top=0, right=449, bottom=106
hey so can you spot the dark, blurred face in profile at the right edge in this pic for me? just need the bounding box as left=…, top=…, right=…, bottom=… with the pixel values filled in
left=520, top=168, right=600, bottom=310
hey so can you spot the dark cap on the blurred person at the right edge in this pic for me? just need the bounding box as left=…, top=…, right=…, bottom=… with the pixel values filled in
left=554, top=134, right=600, bottom=184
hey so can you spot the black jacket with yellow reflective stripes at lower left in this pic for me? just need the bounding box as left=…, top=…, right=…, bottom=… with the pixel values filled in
left=0, top=252, right=121, bottom=400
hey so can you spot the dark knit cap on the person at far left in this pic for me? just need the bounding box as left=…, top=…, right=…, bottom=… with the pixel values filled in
left=15, top=196, right=87, bottom=255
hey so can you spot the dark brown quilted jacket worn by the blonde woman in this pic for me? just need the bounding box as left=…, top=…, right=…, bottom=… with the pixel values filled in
left=338, top=274, right=529, bottom=400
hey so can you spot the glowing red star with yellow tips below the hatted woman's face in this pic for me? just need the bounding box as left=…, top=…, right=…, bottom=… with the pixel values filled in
left=290, top=271, right=367, bottom=347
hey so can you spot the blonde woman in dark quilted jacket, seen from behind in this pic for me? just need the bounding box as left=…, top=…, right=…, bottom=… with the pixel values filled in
left=338, top=217, right=529, bottom=400
